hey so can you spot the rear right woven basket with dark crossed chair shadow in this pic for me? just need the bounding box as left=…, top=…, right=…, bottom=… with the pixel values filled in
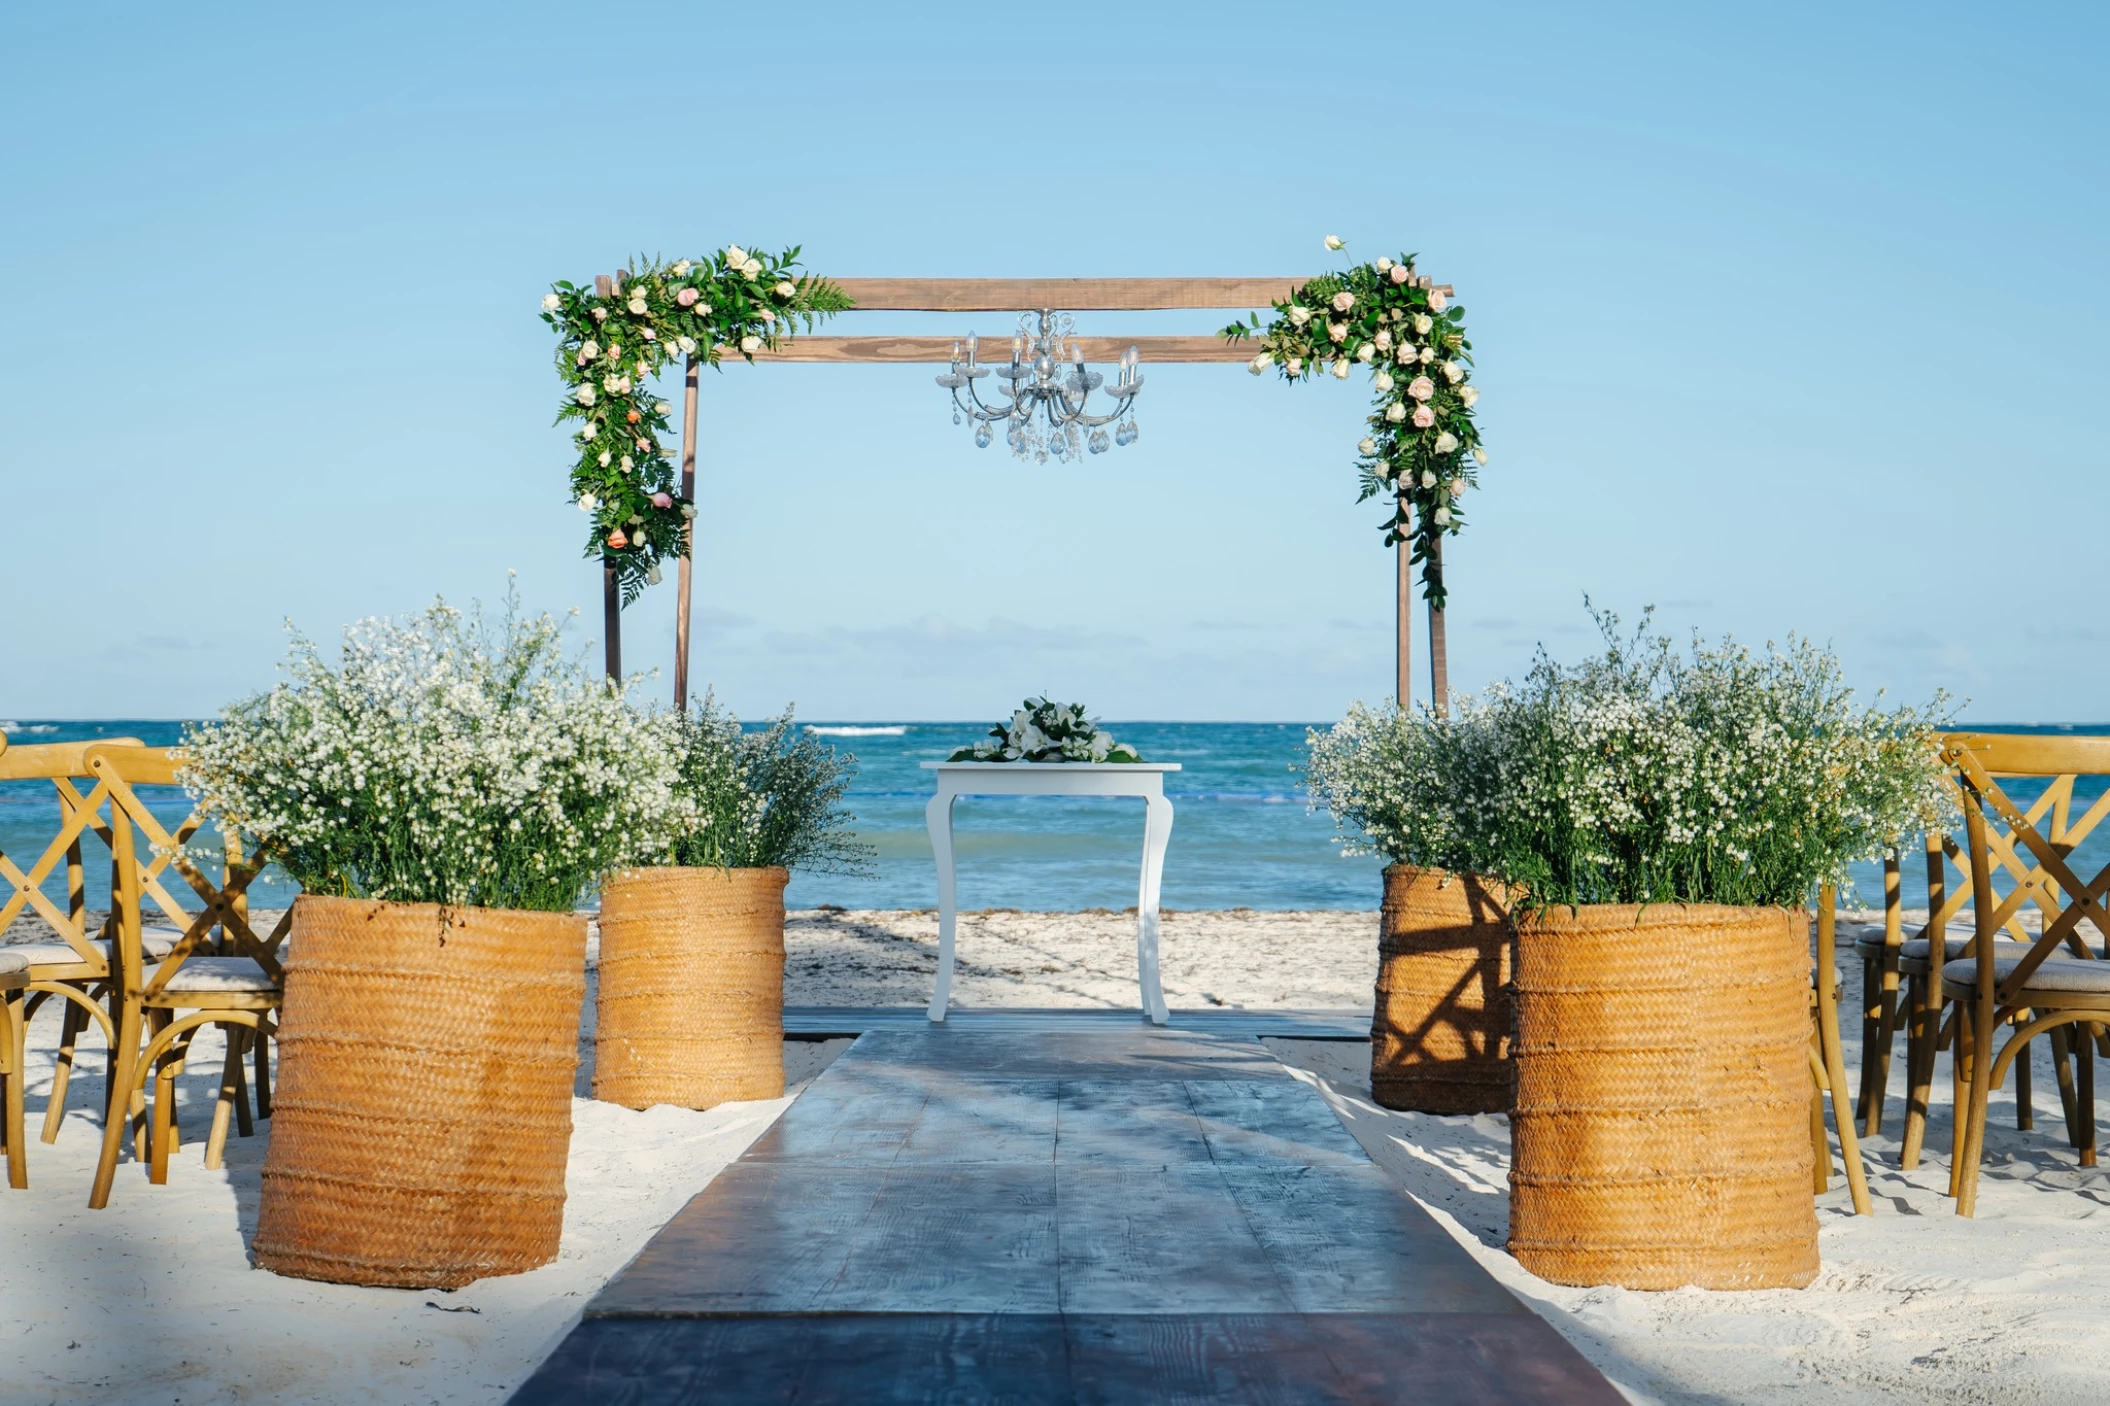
left=1369, top=863, right=1515, bottom=1113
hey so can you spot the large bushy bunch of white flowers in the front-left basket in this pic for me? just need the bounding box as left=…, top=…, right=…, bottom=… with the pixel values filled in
left=181, top=578, right=675, bottom=912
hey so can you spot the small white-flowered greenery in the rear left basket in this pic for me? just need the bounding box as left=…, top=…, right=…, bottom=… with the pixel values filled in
left=660, top=695, right=876, bottom=874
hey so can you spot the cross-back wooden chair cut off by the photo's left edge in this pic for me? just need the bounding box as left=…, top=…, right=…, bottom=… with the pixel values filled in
left=0, top=737, right=150, bottom=1142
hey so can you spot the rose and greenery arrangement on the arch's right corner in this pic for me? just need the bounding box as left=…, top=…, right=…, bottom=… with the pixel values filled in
left=1224, top=234, right=1488, bottom=610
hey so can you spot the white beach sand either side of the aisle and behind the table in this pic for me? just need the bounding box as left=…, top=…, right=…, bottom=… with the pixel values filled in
left=0, top=912, right=2110, bottom=1404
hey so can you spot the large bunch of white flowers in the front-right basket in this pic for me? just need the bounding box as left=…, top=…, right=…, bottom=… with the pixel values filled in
left=1456, top=614, right=1950, bottom=908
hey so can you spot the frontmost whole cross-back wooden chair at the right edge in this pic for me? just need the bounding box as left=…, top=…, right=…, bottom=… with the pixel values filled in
left=1941, top=733, right=2110, bottom=1216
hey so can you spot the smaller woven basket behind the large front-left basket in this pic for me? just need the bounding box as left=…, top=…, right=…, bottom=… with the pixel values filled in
left=593, top=868, right=791, bottom=1108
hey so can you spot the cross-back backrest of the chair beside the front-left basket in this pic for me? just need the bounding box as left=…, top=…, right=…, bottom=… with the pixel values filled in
left=87, top=745, right=293, bottom=996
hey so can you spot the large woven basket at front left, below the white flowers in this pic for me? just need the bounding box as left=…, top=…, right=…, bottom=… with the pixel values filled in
left=253, top=895, right=587, bottom=1288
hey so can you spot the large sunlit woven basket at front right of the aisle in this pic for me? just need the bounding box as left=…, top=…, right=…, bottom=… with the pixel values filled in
left=1509, top=904, right=1819, bottom=1290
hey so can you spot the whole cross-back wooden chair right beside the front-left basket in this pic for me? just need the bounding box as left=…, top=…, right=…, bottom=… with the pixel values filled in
left=87, top=745, right=291, bottom=1208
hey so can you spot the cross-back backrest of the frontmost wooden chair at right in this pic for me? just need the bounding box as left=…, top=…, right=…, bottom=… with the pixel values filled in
left=1943, top=733, right=2110, bottom=1001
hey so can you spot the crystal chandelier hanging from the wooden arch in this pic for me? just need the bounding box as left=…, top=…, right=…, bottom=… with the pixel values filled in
left=937, top=308, right=1144, bottom=464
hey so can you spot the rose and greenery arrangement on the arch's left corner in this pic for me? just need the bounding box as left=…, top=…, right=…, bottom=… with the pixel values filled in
left=542, top=245, right=850, bottom=604
